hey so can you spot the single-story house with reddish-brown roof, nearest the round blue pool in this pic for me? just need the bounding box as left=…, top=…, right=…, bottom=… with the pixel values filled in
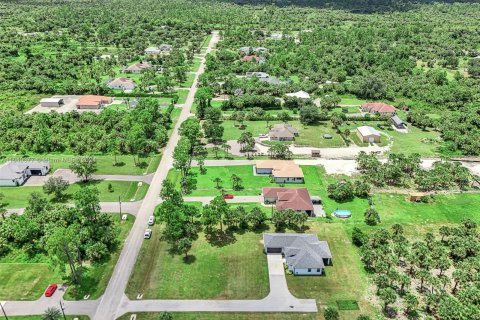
left=262, top=188, right=314, bottom=216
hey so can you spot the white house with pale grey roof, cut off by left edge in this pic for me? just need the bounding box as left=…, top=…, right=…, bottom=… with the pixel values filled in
left=0, top=161, right=50, bottom=187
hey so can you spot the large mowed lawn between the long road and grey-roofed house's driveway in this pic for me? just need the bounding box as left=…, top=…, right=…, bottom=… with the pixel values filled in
left=126, top=225, right=269, bottom=299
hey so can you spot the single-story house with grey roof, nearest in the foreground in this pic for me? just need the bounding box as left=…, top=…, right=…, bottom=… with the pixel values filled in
left=263, top=233, right=332, bottom=275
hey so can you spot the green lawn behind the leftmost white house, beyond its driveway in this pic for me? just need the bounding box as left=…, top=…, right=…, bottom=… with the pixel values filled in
left=0, top=153, right=162, bottom=175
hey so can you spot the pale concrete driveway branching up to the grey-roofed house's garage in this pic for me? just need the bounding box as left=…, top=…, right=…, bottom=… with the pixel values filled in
left=118, top=254, right=318, bottom=315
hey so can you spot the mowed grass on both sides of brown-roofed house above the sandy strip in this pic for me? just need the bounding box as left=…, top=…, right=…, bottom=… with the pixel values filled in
left=222, top=120, right=345, bottom=148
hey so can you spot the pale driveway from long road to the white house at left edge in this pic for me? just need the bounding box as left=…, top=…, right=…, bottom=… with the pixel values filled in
left=24, top=169, right=153, bottom=187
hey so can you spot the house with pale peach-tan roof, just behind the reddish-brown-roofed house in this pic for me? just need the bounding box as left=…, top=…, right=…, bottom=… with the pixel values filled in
left=255, top=160, right=304, bottom=183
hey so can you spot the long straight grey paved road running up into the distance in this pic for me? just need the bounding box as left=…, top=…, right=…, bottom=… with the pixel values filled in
left=93, top=32, right=218, bottom=320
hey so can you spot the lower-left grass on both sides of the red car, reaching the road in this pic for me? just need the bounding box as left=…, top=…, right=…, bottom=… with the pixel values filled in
left=0, top=215, right=135, bottom=300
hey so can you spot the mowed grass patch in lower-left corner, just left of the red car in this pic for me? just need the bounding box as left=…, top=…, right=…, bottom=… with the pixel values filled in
left=0, top=263, right=63, bottom=300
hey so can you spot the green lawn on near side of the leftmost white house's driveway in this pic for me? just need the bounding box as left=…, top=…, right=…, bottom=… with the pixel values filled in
left=0, top=181, right=149, bottom=208
